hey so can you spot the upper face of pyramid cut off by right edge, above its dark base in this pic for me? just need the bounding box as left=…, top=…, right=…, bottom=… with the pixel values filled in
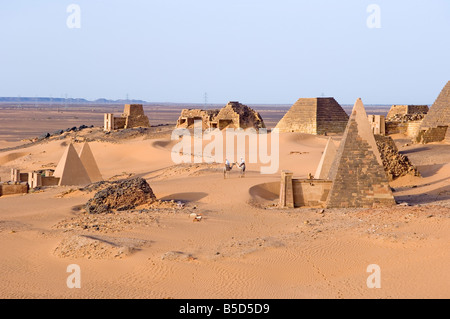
left=420, top=81, right=450, bottom=129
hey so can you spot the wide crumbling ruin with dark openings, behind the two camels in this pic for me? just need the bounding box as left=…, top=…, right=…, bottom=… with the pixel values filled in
left=177, top=102, right=266, bottom=130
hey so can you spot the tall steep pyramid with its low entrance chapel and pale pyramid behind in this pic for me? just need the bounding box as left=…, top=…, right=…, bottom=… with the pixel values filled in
left=279, top=99, right=395, bottom=208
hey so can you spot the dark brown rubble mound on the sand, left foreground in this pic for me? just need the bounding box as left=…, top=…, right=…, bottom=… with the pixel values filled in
left=85, top=177, right=156, bottom=214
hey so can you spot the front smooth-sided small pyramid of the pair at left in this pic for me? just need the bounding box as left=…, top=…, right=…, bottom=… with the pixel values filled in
left=53, top=144, right=91, bottom=186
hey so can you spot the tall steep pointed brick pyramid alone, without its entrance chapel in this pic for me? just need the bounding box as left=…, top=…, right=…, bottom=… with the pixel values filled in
left=327, top=99, right=395, bottom=208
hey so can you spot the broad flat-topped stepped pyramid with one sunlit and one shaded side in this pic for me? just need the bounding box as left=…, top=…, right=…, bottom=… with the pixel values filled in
left=275, top=97, right=348, bottom=135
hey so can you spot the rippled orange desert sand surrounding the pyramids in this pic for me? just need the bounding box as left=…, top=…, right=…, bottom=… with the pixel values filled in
left=0, top=118, right=450, bottom=299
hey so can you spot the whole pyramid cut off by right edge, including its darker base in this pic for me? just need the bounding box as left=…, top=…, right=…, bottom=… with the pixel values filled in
left=414, top=81, right=450, bottom=144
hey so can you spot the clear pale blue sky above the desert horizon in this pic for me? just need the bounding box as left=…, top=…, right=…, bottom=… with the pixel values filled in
left=0, top=0, right=450, bottom=104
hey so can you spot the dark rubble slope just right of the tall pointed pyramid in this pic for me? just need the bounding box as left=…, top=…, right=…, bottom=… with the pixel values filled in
left=375, top=135, right=420, bottom=181
